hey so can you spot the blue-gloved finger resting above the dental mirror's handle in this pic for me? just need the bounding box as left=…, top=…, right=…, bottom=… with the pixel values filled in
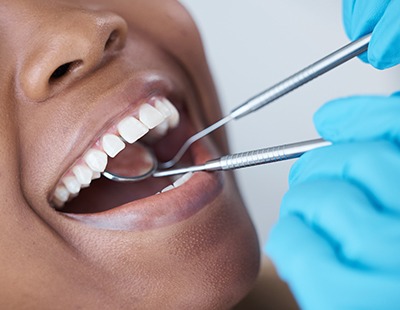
left=314, top=95, right=400, bottom=143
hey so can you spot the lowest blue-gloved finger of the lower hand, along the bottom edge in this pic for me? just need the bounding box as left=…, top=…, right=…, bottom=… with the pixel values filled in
left=265, top=216, right=400, bottom=309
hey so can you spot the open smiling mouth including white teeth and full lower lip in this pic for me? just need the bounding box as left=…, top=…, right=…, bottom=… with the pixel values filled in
left=50, top=91, right=222, bottom=231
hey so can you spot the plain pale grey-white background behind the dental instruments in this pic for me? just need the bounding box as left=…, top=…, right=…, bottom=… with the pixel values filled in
left=181, top=0, right=400, bottom=244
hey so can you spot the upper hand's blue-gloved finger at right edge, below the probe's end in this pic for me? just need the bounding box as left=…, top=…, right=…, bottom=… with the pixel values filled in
left=364, top=1, right=400, bottom=69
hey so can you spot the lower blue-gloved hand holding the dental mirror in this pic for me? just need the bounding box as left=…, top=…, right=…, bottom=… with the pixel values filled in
left=265, top=96, right=400, bottom=309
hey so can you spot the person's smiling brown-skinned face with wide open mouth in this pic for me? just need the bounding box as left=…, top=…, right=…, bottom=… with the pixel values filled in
left=0, top=0, right=259, bottom=309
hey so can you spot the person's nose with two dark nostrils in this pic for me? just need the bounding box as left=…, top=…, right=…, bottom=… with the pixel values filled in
left=19, top=11, right=127, bottom=101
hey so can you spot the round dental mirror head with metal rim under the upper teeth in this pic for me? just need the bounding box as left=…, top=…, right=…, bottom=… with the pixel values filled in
left=102, top=143, right=158, bottom=182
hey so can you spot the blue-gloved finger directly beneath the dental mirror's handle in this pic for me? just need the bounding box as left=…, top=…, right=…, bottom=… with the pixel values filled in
left=289, top=141, right=400, bottom=213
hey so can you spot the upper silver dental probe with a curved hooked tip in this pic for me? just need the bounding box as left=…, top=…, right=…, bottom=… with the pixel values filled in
left=159, top=34, right=371, bottom=169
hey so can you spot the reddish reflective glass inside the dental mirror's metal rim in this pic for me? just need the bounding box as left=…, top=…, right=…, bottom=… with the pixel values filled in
left=106, top=142, right=154, bottom=177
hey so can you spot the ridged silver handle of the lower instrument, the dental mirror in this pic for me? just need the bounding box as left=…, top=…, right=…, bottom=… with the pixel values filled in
left=153, top=139, right=331, bottom=177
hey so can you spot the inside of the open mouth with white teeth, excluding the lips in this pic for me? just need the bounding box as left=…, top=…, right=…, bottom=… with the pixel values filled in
left=50, top=97, right=222, bottom=226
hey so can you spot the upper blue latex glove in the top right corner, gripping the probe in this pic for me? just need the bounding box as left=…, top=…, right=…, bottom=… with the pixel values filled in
left=343, top=0, right=400, bottom=69
